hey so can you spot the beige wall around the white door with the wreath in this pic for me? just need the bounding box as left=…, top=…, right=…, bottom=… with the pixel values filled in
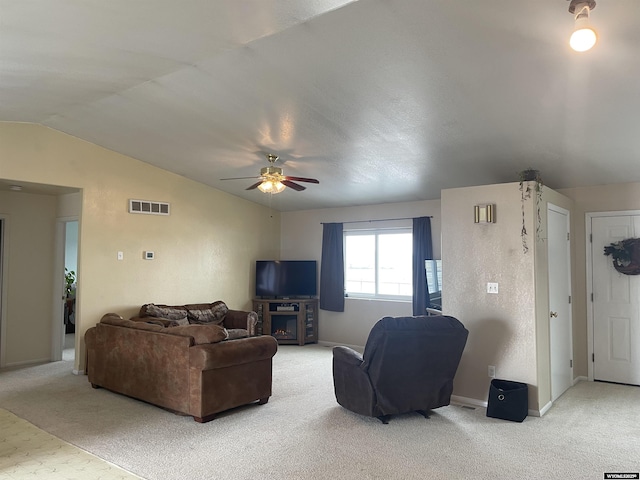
left=558, top=183, right=640, bottom=377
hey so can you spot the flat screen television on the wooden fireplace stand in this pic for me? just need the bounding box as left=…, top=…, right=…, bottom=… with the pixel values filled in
left=256, top=260, right=317, bottom=298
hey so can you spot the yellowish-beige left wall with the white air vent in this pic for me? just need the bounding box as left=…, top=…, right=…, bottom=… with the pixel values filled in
left=0, top=123, right=280, bottom=369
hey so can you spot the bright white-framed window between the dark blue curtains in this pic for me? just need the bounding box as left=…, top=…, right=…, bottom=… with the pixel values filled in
left=344, top=228, right=413, bottom=300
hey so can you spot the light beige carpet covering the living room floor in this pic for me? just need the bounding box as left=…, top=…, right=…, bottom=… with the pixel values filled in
left=0, top=345, right=640, bottom=480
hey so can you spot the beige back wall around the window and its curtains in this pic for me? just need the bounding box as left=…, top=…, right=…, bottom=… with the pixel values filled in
left=281, top=200, right=440, bottom=346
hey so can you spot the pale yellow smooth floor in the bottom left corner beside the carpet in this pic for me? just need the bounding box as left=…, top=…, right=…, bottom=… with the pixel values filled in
left=0, top=409, right=140, bottom=480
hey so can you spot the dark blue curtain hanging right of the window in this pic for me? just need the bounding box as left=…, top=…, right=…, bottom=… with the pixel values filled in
left=413, top=217, right=433, bottom=315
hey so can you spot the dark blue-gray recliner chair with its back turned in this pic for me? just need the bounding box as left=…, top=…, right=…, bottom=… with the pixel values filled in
left=333, top=316, right=469, bottom=423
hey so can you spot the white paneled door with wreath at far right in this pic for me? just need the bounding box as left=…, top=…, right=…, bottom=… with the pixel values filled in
left=591, top=215, right=640, bottom=385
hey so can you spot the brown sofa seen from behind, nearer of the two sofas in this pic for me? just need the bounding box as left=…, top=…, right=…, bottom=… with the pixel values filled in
left=85, top=304, right=278, bottom=423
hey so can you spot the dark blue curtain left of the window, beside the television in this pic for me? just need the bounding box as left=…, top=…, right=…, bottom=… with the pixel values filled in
left=320, top=223, right=344, bottom=312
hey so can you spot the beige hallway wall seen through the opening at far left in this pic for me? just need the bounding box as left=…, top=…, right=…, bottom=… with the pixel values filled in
left=0, top=192, right=57, bottom=365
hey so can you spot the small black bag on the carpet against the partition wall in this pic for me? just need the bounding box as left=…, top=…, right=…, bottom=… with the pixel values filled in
left=487, top=378, right=529, bottom=422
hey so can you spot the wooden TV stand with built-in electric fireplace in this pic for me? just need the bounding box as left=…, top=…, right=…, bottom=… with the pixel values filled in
left=253, top=298, right=318, bottom=345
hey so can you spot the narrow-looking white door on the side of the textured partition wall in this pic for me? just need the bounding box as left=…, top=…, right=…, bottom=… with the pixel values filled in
left=547, top=204, right=573, bottom=401
